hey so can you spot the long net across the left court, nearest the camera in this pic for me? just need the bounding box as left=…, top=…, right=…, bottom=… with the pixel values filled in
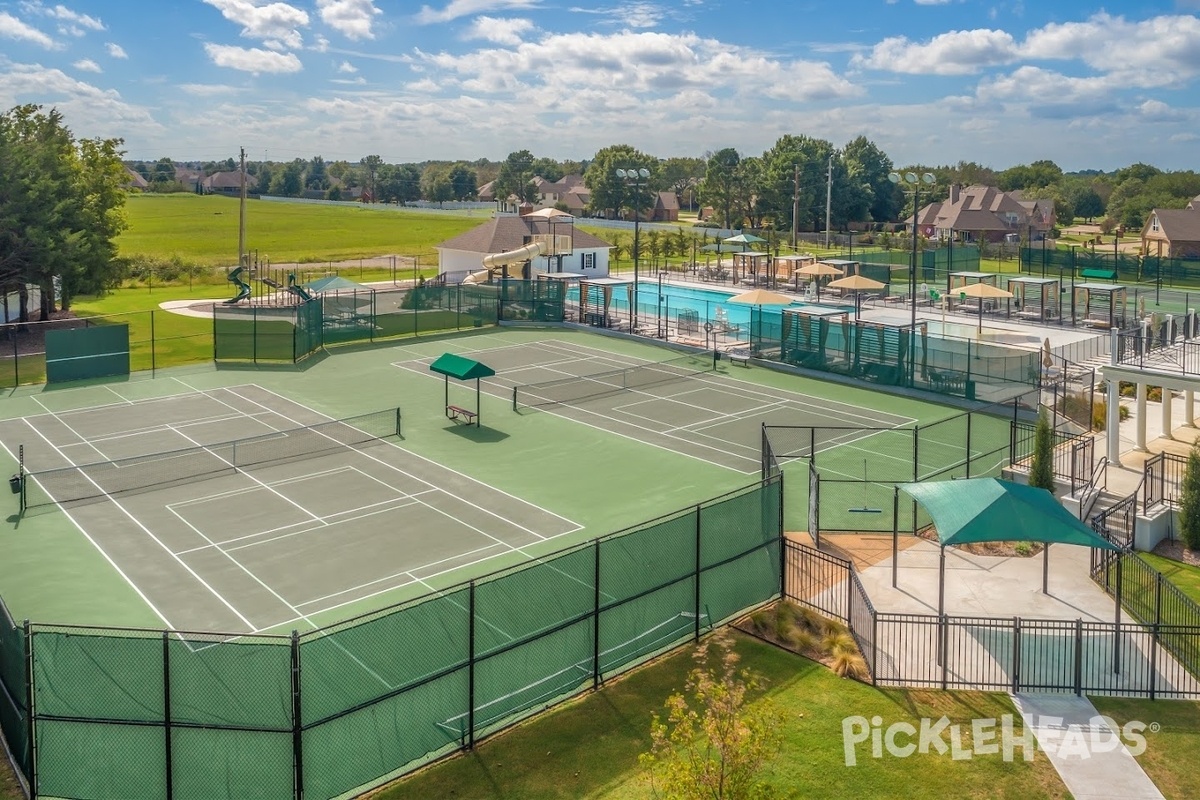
left=22, top=408, right=401, bottom=509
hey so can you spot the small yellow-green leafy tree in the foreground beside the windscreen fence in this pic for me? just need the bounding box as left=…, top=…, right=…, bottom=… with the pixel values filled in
left=640, top=628, right=781, bottom=800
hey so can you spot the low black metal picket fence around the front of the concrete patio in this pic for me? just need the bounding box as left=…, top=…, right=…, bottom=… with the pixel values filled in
left=784, top=541, right=1200, bottom=699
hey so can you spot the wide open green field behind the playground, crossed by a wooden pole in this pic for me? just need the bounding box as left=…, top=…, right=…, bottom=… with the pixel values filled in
left=118, top=194, right=486, bottom=266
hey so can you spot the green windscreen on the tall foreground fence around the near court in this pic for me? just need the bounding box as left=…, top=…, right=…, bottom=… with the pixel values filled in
left=21, top=477, right=782, bottom=800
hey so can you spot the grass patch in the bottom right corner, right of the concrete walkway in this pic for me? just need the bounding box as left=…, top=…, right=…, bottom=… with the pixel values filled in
left=1091, top=697, right=1200, bottom=799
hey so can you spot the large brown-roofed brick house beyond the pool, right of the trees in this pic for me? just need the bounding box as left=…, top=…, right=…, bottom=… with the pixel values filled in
left=905, top=185, right=1052, bottom=241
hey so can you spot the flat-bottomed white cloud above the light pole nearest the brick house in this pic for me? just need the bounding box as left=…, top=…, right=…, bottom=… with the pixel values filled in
left=851, top=29, right=1018, bottom=76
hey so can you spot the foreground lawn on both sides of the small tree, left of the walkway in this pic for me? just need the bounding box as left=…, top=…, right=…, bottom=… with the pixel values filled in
left=372, top=634, right=1068, bottom=800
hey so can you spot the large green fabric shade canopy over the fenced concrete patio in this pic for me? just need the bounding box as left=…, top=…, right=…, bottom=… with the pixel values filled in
left=900, top=477, right=1121, bottom=551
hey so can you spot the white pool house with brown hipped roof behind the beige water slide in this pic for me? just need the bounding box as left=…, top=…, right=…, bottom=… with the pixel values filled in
left=434, top=216, right=612, bottom=283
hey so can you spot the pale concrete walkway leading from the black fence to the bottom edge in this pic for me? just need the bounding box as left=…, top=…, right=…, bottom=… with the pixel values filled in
left=1013, top=694, right=1163, bottom=800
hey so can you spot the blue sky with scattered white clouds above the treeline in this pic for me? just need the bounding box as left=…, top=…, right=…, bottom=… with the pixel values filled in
left=0, top=0, right=1200, bottom=170
